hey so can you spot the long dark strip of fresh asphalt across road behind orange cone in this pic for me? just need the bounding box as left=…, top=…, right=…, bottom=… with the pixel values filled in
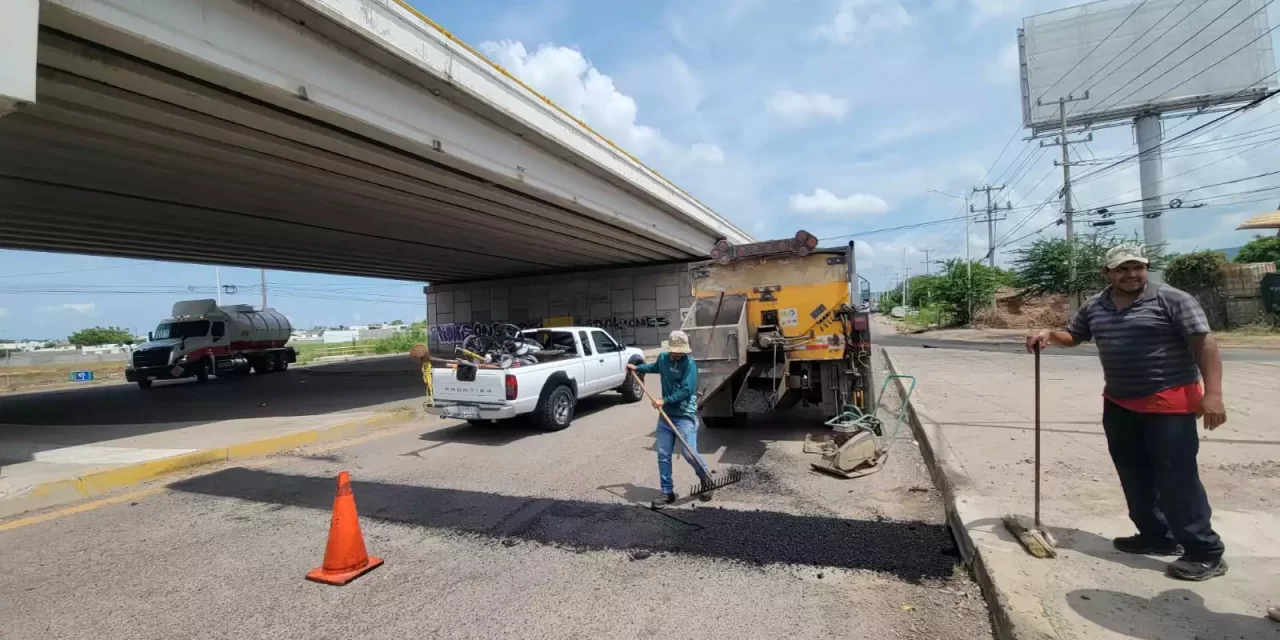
left=169, top=467, right=955, bottom=582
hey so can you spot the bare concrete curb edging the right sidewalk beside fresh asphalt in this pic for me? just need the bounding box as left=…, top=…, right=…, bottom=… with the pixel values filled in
left=881, top=348, right=1059, bottom=640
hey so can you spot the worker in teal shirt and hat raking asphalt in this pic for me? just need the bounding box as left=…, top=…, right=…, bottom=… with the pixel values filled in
left=627, top=330, right=712, bottom=508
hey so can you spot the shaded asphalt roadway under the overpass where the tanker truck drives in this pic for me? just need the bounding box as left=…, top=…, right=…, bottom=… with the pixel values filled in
left=0, top=356, right=422, bottom=429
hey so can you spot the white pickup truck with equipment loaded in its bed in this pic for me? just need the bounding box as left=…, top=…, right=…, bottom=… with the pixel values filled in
left=425, top=326, right=644, bottom=431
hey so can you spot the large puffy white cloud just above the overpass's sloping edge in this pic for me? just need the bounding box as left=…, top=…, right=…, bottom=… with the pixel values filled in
left=480, top=40, right=724, bottom=164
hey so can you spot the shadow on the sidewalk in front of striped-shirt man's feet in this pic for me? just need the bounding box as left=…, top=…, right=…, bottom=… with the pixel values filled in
left=1066, top=589, right=1280, bottom=640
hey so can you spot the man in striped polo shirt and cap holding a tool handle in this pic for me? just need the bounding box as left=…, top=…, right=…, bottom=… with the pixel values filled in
left=1027, top=246, right=1226, bottom=580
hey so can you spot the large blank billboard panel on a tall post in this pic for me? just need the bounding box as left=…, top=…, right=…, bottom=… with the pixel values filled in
left=1018, top=0, right=1276, bottom=134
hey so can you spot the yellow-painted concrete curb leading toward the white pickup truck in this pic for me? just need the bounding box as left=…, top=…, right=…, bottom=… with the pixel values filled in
left=0, top=408, right=416, bottom=518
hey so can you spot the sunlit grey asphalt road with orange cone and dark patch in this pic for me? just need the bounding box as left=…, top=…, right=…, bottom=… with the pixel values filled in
left=0, top=350, right=991, bottom=640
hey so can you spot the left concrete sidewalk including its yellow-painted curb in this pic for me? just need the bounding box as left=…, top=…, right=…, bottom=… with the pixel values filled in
left=0, top=404, right=412, bottom=517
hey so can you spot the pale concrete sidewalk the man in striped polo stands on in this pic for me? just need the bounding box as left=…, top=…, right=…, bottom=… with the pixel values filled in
left=886, top=347, right=1280, bottom=640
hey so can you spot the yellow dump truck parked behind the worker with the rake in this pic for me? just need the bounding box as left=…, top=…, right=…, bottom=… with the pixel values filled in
left=681, top=230, right=874, bottom=426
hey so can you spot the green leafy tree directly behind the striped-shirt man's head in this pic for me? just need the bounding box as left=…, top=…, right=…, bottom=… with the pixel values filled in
left=1014, top=233, right=1164, bottom=296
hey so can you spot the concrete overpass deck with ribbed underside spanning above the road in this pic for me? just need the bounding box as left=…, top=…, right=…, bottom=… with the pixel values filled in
left=0, top=0, right=751, bottom=283
